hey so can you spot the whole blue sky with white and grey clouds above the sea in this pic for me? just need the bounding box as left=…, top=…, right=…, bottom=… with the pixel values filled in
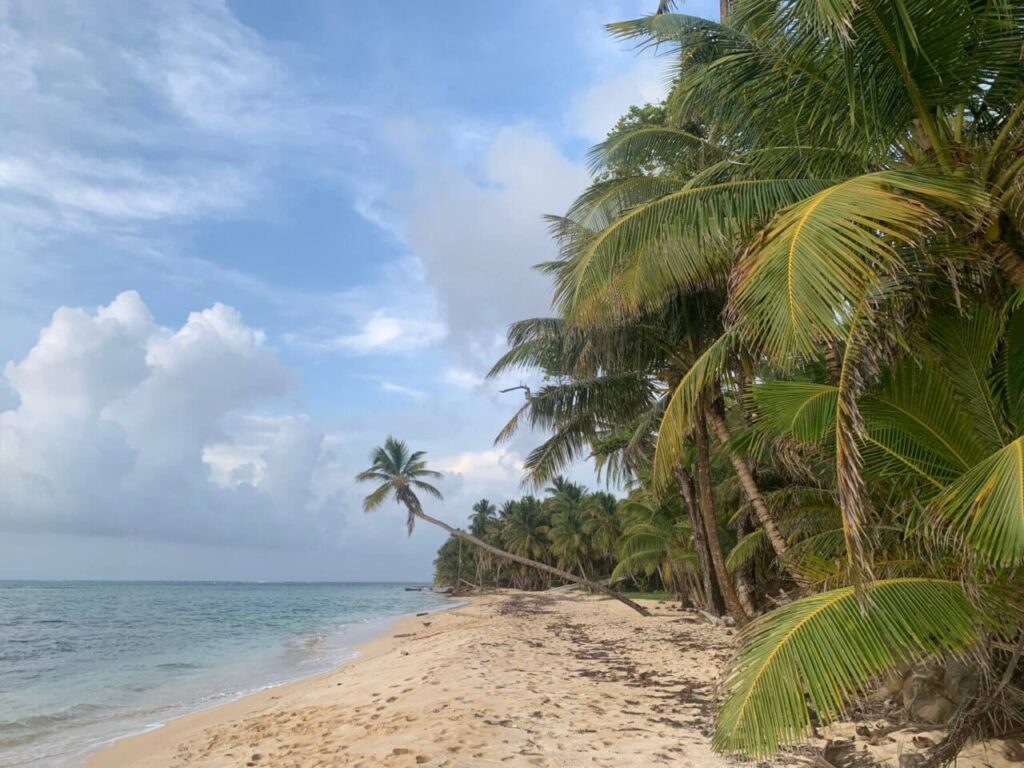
left=0, top=0, right=717, bottom=581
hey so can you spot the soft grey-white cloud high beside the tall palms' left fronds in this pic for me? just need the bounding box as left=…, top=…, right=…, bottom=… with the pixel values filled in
left=406, top=125, right=588, bottom=361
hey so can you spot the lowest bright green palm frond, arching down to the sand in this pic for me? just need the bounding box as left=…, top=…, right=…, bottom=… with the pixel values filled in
left=714, top=579, right=981, bottom=758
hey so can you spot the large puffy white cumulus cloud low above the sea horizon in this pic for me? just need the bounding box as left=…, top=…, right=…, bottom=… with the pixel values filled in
left=0, top=292, right=341, bottom=543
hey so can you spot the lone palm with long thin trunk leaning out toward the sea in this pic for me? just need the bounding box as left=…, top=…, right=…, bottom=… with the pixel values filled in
left=355, top=435, right=650, bottom=615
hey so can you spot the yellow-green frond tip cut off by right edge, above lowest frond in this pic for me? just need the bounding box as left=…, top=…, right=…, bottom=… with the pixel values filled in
left=932, top=436, right=1024, bottom=567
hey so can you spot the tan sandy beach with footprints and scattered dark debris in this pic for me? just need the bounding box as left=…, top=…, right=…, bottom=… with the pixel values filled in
left=88, top=594, right=732, bottom=768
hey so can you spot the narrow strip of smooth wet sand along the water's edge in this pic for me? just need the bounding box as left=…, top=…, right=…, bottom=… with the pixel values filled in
left=84, top=597, right=464, bottom=768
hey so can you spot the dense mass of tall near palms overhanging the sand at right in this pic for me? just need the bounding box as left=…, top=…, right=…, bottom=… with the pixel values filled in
left=440, top=0, right=1024, bottom=760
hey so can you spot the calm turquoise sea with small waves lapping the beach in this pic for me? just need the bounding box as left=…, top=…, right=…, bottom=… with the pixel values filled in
left=0, top=582, right=449, bottom=766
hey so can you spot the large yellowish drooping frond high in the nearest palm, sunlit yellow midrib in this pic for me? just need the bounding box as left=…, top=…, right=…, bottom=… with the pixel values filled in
left=731, top=171, right=982, bottom=359
